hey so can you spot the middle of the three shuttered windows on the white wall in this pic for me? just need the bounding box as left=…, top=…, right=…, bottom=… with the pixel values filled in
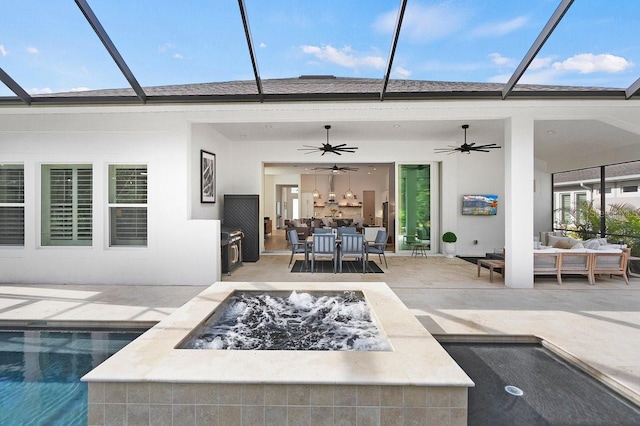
left=41, top=164, right=93, bottom=246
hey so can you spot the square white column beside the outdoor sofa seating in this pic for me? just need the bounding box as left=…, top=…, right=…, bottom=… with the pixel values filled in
left=504, top=116, right=534, bottom=288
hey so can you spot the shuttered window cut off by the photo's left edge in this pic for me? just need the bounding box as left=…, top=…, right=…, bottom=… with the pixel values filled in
left=0, top=164, right=24, bottom=246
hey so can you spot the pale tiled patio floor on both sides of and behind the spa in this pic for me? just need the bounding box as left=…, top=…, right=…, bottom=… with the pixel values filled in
left=0, top=251, right=640, bottom=403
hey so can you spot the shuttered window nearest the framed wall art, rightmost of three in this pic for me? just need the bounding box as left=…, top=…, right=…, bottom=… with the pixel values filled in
left=109, top=164, right=147, bottom=247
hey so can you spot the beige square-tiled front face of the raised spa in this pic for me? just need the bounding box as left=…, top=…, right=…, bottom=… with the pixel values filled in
left=89, top=382, right=467, bottom=426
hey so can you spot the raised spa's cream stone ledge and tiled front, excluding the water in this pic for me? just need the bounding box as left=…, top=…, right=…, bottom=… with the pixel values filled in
left=83, top=282, right=474, bottom=425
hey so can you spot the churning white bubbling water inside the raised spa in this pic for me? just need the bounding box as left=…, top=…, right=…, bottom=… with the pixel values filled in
left=182, top=291, right=391, bottom=351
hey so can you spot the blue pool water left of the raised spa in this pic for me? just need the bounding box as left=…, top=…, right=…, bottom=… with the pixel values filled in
left=0, top=330, right=141, bottom=426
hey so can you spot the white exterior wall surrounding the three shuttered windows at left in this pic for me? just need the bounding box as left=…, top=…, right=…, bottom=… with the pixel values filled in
left=0, top=108, right=220, bottom=285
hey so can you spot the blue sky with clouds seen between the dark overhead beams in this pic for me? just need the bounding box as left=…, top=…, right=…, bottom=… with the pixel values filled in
left=0, top=0, right=640, bottom=96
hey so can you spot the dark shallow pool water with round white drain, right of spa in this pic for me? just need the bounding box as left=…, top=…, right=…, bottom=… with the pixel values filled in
left=440, top=342, right=640, bottom=426
